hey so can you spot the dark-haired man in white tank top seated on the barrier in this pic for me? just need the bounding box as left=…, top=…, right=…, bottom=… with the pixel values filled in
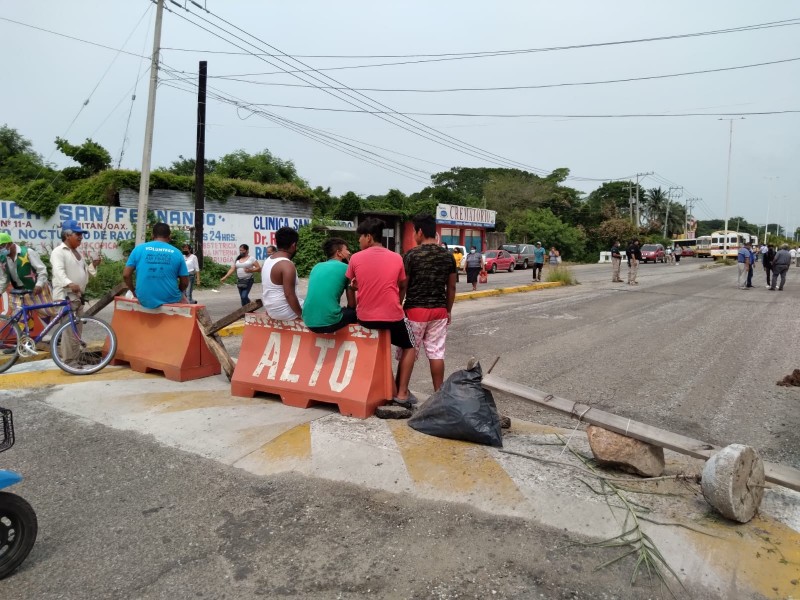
left=261, top=227, right=303, bottom=321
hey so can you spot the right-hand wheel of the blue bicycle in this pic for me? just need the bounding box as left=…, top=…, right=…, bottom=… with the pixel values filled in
left=50, top=317, right=117, bottom=375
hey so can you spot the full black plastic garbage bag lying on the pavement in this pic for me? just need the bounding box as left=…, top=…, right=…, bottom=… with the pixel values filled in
left=408, top=363, right=503, bottom=448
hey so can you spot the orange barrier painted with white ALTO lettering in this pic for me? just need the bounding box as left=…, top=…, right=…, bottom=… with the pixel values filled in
left=231, top=313, right=392, bottom=419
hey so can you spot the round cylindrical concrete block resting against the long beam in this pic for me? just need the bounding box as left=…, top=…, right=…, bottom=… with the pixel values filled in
left=701, top=444, right=764, bottom=523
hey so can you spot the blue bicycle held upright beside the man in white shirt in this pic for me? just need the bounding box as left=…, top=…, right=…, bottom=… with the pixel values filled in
left=0, top=290, right=117, bottom=375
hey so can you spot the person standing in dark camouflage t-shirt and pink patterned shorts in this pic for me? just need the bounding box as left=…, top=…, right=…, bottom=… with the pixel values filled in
left=403, top=214, right=456, bottom=391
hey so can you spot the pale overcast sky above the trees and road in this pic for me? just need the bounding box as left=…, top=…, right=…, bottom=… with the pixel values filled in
left=0, top=0, right=800, bottom=230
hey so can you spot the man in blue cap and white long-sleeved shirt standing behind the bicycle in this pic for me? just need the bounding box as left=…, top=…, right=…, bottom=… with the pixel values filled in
left=50, top=219, right=101, bottom=362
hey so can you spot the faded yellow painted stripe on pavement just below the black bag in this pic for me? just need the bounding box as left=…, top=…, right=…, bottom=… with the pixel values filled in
left=387, top=421, right=525, bottom=507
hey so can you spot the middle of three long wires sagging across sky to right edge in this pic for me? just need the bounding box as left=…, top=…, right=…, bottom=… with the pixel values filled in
left=177, top=57, right=800, bottom=94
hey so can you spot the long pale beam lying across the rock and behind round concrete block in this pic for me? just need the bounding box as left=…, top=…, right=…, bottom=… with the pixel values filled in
left=483, top=374, right=800, bottom=492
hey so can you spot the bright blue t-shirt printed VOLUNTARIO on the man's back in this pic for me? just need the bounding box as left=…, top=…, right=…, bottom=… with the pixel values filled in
left=125, top=241, right=189, bottom=308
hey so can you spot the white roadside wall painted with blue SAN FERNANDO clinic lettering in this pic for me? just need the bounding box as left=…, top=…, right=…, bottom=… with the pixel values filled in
left=0, top=200, right=355, bottom=264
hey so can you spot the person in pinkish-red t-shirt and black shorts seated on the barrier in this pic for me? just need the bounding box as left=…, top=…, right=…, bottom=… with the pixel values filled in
left=346, top=217, right=417, bottom=405
